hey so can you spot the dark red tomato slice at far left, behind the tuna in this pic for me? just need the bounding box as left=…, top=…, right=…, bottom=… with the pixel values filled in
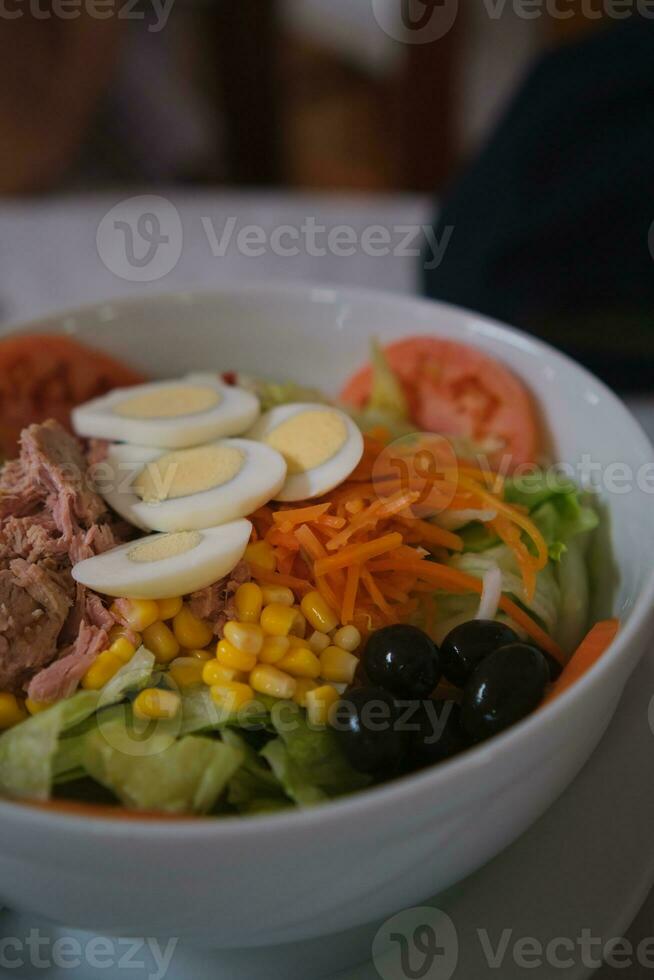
left=0, top=334, right=145, bottom=457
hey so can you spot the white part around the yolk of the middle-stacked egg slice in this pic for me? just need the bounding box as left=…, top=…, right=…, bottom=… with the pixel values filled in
left=95, top=439, right=286, bottom=531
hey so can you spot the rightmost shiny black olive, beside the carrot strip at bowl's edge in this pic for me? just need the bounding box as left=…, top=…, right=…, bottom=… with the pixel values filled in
left=461, top=643, right=550, bottom=742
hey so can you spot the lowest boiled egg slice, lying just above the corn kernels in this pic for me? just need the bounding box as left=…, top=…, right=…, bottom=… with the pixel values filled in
left=73, top=520, right=252, bottom=599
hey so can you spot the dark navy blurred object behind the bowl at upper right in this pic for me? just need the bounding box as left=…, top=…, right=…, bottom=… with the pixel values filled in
left=425, top=17, right=654, bottom=390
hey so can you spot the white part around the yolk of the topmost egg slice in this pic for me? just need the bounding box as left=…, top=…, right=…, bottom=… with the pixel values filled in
left=72, top=374, right=259, bottom=449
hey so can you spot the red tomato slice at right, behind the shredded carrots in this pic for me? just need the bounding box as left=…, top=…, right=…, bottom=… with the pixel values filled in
left=341, top=337, right=540, bottom=469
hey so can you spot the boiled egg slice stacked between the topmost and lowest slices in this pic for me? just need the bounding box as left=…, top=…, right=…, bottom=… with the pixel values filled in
left=95, top=439, right=286, bottom=531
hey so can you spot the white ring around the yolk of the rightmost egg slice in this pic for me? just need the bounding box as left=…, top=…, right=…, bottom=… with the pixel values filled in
left=248, top=403, right=363, bottom=502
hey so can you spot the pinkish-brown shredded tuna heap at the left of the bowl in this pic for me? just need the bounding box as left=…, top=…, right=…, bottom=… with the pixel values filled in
left=0, top=421, right=131, bottom=700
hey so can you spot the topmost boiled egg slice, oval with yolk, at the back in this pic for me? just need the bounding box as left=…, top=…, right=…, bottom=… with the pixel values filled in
left=72, top=374, right=259, bottom=449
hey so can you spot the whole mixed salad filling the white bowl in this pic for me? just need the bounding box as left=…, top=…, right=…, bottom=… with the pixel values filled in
left=0, top=337, right=618, bottom=816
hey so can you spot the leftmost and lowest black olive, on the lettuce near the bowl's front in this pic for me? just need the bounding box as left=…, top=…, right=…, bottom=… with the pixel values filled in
left=332, top=687, right=407, bottom=776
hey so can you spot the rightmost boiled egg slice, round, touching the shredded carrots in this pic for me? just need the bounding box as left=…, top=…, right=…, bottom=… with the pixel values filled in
left=248, top=404, right=363, bottom=501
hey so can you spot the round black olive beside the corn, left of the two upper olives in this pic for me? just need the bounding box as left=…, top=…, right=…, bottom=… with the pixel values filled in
left=363, top=624, right=441, bottom=699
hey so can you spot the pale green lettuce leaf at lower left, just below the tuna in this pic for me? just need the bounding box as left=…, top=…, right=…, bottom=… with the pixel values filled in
left=0, top=647, right=154, bottom=800
